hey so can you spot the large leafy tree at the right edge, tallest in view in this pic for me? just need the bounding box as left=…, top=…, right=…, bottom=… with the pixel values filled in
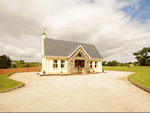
left=133, top=47, right=150, bottom=66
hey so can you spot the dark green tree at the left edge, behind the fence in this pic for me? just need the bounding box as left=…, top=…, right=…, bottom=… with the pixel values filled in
left=0, top=55, right=11, bottom=69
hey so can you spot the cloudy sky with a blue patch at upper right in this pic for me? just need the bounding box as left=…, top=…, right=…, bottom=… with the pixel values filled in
left=0, top=0, right=150, bottom=62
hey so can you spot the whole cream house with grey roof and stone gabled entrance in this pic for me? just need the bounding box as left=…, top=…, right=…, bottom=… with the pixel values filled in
left=42, top=33, right=102, bottom=74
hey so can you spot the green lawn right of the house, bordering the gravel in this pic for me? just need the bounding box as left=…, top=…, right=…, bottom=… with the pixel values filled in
left=102, top=66, right=150, bottom=90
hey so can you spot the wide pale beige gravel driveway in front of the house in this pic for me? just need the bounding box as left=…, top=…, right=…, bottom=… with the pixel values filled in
left=0, top=71, right=150, bottom=112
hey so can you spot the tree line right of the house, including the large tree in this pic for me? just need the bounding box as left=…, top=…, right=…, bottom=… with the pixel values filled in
left=102, top=47, right=150, bottom=66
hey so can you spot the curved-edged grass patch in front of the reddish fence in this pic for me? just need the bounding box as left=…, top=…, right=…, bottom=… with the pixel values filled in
left=0, top=73, right=23, bottom=91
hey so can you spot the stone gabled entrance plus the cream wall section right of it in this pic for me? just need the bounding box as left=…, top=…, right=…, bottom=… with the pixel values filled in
left=68, top=45, right=102, bottom=74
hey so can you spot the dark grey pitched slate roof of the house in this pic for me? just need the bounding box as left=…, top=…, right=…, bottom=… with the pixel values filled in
left=44, top=38, right=103, bottom=59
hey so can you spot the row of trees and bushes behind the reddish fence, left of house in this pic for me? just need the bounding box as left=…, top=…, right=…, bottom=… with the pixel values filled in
left=0, top=55, right=42, bottom=69
